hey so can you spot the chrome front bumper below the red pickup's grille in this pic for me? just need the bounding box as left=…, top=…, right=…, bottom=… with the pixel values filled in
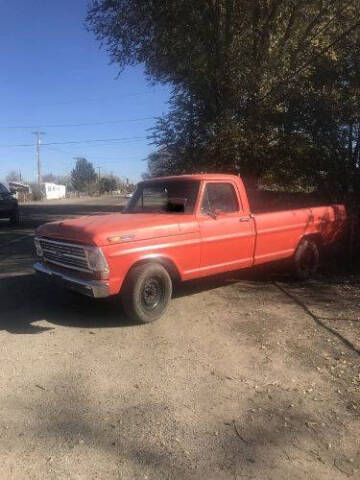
left=34, top=262, right=110, bottom=298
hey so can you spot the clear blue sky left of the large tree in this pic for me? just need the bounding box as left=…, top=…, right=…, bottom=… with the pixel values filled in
left=0, top=0, right=169, bottom=180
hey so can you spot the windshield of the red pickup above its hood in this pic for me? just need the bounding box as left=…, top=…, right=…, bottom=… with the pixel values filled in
left=125, top=180, right=200, bottom=214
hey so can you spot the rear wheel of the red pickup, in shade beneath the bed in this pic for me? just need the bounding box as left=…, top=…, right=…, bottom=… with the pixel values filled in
left=294, top=238, right=320, bottom=280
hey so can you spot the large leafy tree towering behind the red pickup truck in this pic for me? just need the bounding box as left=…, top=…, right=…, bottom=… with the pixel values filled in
left=88, top=0, right=360, bottom=197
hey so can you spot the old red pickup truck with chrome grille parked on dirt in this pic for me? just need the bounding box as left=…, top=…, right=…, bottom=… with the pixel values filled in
left=34, top=174, right=346, bottom=322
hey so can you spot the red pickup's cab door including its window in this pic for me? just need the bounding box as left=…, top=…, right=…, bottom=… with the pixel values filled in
left=199, top=182, right=255, bottom=274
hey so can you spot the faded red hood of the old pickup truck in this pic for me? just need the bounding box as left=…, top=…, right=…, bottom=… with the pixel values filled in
left=36, top=213, right=199, bottom=247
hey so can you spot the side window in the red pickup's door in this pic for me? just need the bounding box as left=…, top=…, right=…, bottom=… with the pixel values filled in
left=201, top=183, right=239, bottom=214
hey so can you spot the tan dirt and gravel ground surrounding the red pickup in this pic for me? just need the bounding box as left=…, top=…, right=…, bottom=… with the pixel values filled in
left=0, top=199, right=360, bottom=480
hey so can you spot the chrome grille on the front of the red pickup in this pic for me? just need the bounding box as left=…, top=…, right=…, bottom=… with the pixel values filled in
left=39, top=238, right=91, bottom=272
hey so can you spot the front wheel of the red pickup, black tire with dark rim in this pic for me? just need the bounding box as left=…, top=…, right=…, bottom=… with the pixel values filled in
left=121, top=263, right=172, bottom=323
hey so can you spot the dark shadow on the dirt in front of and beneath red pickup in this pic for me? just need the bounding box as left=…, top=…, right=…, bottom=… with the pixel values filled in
left=0, top=265, right=358, bottom=334
